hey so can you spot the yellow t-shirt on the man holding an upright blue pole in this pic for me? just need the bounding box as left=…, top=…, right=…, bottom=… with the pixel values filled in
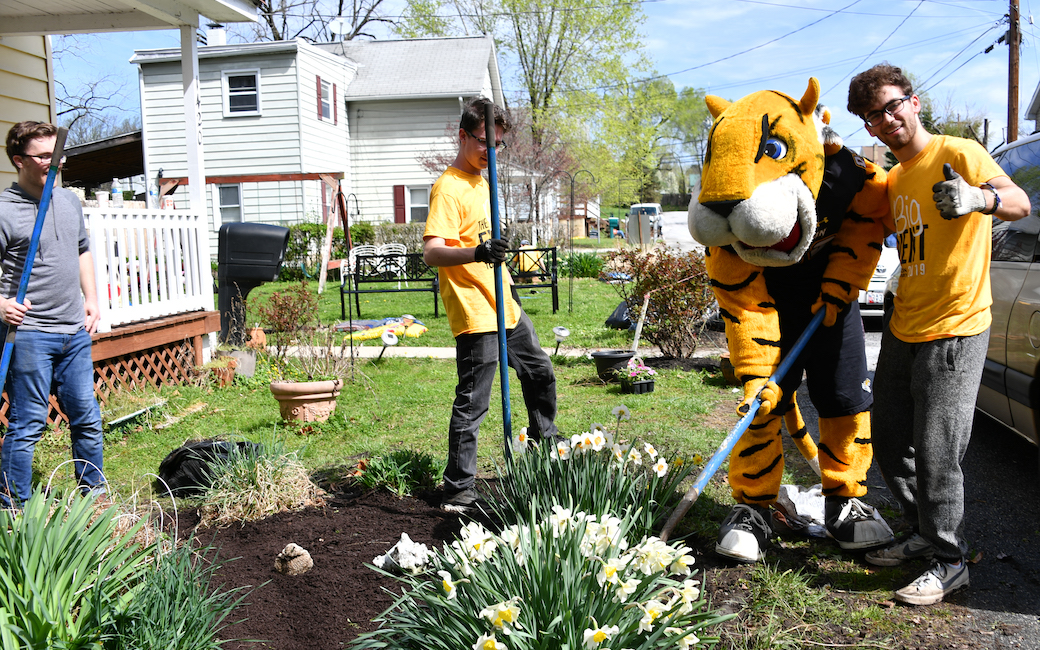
left=422, top=167, right=520, bottom=336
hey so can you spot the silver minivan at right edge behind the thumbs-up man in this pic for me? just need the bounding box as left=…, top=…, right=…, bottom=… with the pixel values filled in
left=976, top=134, right=1040, bottom=453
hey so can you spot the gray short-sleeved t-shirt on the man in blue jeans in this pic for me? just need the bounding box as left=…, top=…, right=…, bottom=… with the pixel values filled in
left=0, top=183, right=89, bottom=334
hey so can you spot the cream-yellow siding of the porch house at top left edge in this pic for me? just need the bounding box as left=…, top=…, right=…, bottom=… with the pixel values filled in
left=0, top=35, right=55, bottom=188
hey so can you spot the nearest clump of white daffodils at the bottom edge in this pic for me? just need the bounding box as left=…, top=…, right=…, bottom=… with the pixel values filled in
left=354, top=499, right=731, bottom=650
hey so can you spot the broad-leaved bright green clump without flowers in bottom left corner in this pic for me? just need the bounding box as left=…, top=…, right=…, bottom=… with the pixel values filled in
left=0, top=491, right=153, bottom=650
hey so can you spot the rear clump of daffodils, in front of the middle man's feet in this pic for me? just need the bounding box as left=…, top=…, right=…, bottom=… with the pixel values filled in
left=493, top=405, right=694, bottom=535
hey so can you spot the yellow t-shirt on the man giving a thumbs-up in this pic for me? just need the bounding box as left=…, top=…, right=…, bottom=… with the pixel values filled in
left=888, top=135, right=1006, bottom=343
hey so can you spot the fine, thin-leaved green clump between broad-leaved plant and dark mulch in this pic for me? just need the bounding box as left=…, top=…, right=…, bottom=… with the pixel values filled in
left=106, top=540, right=253, bottom=650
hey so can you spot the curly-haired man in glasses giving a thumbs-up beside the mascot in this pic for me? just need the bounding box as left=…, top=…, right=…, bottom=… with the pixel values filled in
left=849, top=63, right=1030, bottom=604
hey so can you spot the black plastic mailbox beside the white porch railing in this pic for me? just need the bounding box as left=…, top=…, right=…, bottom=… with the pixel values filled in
left=216, top=224, right=289, bottom=345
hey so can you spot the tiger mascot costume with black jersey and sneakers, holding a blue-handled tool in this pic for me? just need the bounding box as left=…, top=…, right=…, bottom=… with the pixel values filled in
left=688, top=78, right=893, bottom=562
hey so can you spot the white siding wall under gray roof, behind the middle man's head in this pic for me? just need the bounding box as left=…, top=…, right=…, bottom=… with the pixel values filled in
left=347, top=98, right=461, bottom=222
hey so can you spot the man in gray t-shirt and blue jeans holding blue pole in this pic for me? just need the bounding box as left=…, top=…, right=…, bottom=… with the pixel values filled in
left=0, top=122, right=105, bottom=505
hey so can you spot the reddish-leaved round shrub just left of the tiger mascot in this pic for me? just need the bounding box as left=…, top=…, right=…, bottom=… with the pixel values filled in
left=607, top=249, right=716, bottom=359
